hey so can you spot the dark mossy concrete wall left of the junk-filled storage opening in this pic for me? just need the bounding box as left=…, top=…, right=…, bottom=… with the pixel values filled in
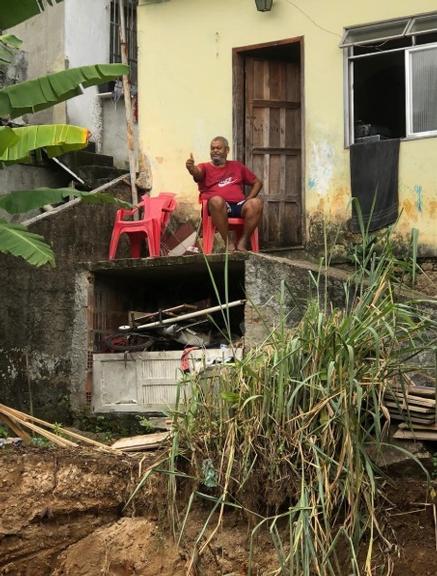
left=0, top=186, right=129, bottom=421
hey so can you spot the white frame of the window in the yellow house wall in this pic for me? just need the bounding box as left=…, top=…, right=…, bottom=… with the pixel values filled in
left=340, top=12, right=437, bottom=148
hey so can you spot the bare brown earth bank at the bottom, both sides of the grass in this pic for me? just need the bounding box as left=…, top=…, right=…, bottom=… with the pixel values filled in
left=0, top=449, right=437, bottom=576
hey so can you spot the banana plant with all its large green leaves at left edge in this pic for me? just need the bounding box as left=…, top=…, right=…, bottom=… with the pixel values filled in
left=0, top=0, right=129, bottom=266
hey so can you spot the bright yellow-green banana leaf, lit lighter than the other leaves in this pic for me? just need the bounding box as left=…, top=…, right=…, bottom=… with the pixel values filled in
left=0, top=124, right=90, bottom=164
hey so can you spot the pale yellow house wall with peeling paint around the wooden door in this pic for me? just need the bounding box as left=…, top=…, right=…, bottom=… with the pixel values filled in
left=138, top=0, right=437, bottom=253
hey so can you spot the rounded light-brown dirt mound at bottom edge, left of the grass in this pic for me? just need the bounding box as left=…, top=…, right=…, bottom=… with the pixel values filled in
left=52, top=518, right=186, bottom=576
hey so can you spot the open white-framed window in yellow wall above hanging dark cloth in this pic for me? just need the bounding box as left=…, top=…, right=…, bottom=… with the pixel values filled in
left=341, top=13, right=437, bottom=145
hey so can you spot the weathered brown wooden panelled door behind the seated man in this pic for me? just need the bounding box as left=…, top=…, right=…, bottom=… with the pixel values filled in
left=244, top=57, right=302, bottom=248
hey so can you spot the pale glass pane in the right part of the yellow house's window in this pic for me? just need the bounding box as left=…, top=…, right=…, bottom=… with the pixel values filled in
left=410, top=47, right=437, bottom=133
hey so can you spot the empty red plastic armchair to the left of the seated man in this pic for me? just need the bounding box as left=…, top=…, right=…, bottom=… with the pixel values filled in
left=109, top=192, right=176, bottom=260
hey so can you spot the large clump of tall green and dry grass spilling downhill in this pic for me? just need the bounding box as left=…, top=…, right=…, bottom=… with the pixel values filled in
left=129, top=218, right=428, bottom=576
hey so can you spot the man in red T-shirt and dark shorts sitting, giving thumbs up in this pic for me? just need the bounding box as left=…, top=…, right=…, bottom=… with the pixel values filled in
left=185, top=136, right=263, bottom=252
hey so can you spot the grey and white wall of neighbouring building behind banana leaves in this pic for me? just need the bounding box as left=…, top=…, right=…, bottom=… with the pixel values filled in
left=6, top=0, right=128, bottom=168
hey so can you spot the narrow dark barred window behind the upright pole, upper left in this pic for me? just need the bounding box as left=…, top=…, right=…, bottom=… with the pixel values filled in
left=109, top=0, right=138, bottom=86
